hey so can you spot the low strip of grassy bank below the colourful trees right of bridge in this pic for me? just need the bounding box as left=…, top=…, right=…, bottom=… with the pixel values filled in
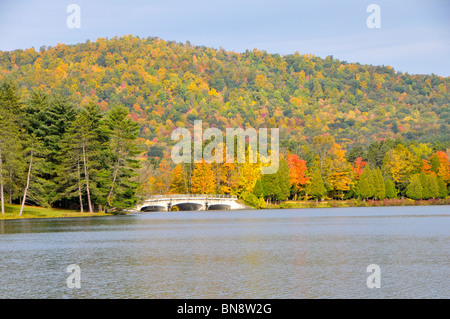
left=266, top=198, right=450, bottom=209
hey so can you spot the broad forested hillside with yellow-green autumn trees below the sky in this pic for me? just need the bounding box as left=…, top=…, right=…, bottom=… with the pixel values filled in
left=0, top=36, right=450, bottom=156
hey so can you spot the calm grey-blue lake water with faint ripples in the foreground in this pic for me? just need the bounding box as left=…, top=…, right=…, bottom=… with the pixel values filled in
left=0, top=206, right=450, bottom=299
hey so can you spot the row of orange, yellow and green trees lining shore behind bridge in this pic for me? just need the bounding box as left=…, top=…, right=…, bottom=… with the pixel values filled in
left=139, top=135, right=450, bottom=207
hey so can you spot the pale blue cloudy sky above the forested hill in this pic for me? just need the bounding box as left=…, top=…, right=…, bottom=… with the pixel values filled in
left=0, top=0, right=450, bottom=76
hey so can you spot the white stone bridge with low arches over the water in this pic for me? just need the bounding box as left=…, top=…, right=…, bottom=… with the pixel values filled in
left=136, top=194, right=248, bottom=212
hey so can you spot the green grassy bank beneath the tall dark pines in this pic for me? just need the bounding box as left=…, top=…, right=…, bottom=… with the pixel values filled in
left=0, top=204, right=111, bottom=219
